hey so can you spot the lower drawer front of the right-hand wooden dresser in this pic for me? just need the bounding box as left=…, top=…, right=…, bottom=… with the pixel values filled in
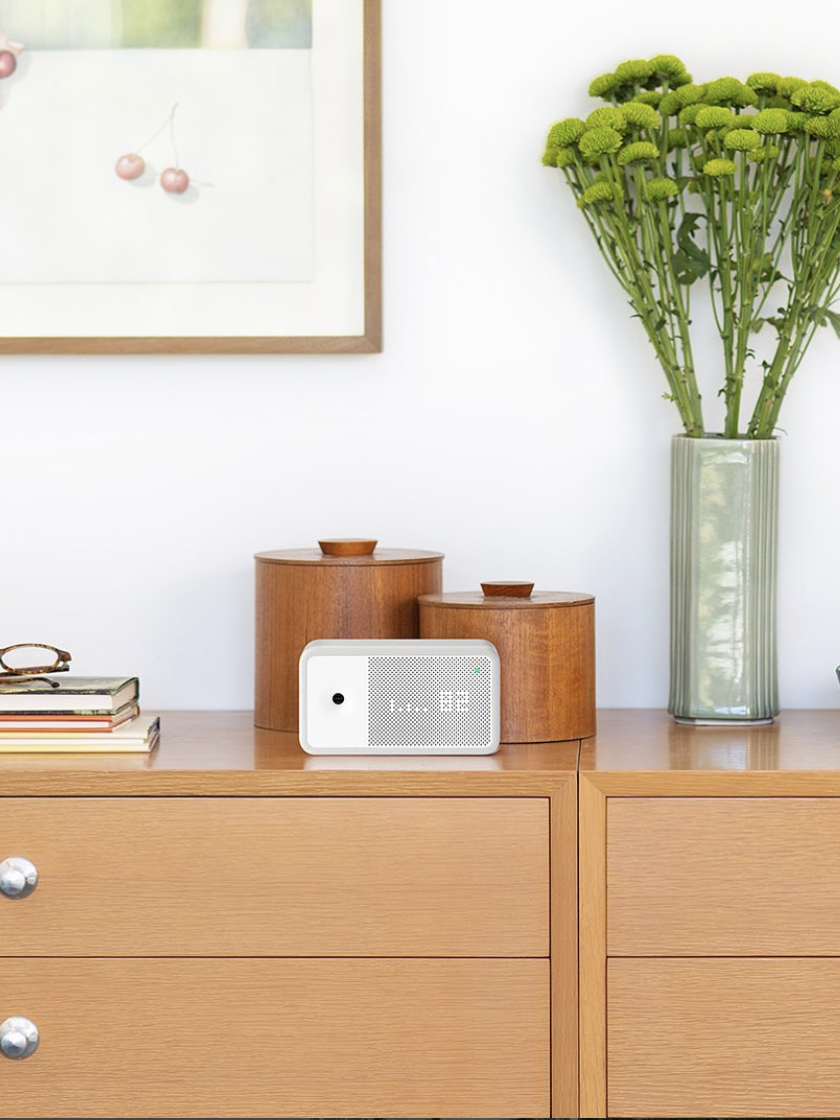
left=608, top=958, right=840, bottom=1117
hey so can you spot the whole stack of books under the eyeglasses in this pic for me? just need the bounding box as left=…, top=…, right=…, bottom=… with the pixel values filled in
left=0, top=676, right=160, bottom=754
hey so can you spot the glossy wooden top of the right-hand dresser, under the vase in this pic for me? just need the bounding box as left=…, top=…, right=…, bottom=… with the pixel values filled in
left=580, top=709, right=840, bottom=782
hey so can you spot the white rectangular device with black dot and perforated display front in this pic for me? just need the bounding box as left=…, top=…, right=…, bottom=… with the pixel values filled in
left=299, top=638, right=501, bottom=755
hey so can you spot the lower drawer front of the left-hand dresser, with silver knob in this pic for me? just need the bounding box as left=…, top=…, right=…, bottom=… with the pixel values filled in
left=0, top=959, right=549, bottom=1117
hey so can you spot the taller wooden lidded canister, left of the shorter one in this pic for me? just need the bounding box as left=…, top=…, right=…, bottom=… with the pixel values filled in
left=254, top=540, right=444, bottom=731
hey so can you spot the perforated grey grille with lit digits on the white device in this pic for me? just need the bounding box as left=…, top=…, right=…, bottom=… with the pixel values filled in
left=367, top=654, right=493, bottom=747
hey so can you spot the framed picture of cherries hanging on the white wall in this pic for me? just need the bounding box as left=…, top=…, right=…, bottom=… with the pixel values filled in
left=0, top=0, right=382, bottom=354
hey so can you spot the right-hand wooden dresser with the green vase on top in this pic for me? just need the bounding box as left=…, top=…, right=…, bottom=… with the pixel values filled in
left=579, top=711, right=840, bottom=1118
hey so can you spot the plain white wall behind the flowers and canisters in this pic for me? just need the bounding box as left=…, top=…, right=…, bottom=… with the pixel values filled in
left=0, top=0, right=840, bottom=708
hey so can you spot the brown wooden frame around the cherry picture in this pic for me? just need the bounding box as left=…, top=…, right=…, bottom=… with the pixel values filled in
left=0, top=0, right=382, bottom=355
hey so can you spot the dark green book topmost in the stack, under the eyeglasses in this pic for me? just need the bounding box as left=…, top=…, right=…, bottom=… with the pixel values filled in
left=0, top=676, right=140, bottom=716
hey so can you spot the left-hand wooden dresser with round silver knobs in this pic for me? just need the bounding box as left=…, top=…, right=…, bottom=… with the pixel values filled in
left=0, top=712, right=578, bottom=1118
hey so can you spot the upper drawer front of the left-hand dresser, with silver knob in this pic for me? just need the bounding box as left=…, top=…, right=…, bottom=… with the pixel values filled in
left=0, top=797, right=549, bottom=956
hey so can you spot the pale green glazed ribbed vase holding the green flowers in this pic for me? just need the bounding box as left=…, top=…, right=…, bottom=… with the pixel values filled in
left=669, top=436, right=780, bottom=724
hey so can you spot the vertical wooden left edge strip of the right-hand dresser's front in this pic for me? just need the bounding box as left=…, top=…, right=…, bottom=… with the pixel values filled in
left=578, top=776, right=607, bottom=1118
